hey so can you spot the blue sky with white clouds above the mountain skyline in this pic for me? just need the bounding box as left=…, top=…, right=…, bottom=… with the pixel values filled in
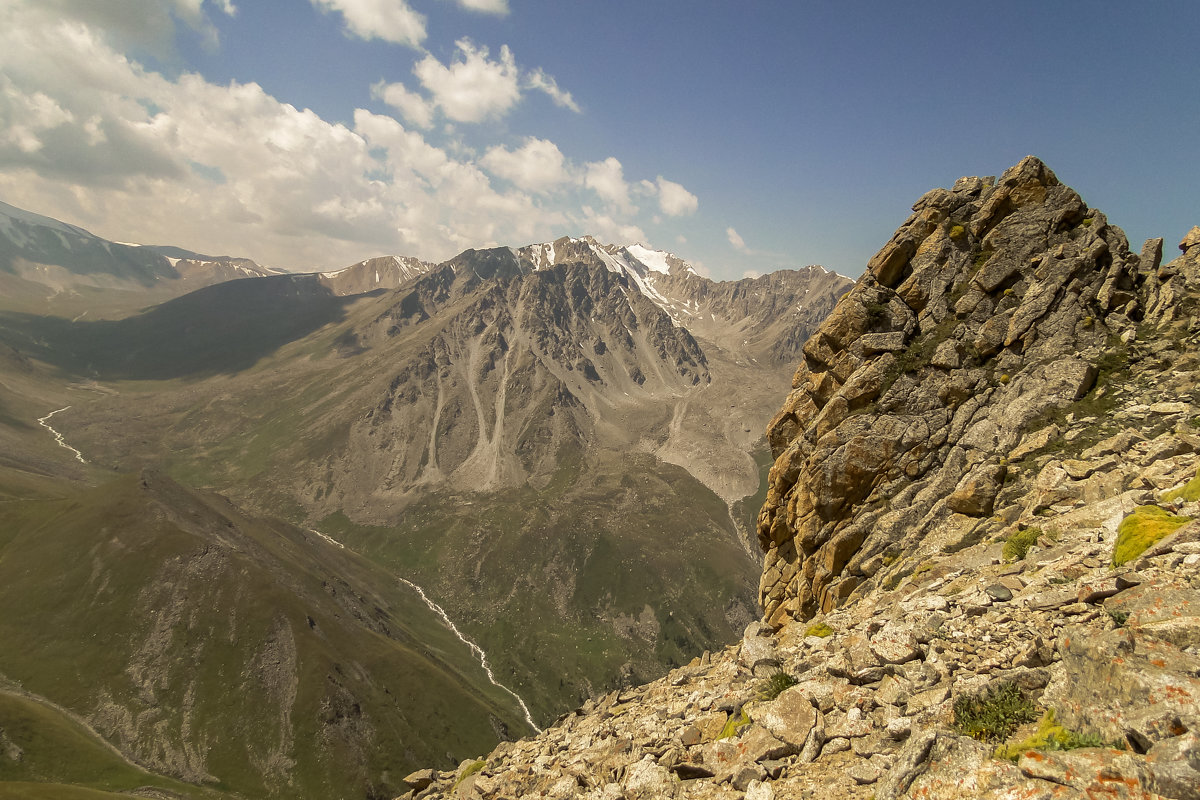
left=0, top=0, right=1200, bottom=279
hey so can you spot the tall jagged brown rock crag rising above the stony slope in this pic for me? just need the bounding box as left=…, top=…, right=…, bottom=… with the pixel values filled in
left=758, top=157, right=1142, bottom=624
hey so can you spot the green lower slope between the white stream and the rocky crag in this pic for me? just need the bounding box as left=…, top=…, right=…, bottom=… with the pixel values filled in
left=322, top=455, right=755, bottom=722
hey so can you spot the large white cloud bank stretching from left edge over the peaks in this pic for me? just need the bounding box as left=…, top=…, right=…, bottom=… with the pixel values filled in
left=0, top=0, right=696, bottom=269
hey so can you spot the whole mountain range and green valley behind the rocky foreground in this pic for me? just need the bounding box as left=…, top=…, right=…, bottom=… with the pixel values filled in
left=0, top=196, right=851, bottom=798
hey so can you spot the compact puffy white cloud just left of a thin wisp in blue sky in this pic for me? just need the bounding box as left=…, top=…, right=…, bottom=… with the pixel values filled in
left=413, top=38, right=521, bottom=122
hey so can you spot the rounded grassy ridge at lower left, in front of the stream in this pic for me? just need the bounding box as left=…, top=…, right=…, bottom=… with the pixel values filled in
left=0, top=475, right=524, bottom=798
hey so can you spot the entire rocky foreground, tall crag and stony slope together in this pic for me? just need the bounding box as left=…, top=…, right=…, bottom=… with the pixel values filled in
left=404, top=160, right=1200, bottom=800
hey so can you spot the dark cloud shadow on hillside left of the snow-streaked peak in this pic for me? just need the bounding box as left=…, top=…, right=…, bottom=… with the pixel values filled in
left=0, top=275, right=361, bottom=380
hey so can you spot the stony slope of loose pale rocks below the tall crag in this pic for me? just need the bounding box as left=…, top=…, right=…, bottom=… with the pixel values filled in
left=398, top=422, right=1200, bottom=800
